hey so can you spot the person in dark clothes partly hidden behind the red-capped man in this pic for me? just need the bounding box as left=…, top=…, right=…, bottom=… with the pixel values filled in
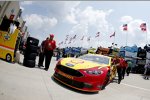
left=38, top=37, right=49, bottom=67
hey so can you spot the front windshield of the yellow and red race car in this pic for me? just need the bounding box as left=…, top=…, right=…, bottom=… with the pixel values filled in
left=79, top=55, right=109, bottom=65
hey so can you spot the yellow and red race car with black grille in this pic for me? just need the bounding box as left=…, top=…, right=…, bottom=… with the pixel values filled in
left=53, top=54, right=116, bottom=92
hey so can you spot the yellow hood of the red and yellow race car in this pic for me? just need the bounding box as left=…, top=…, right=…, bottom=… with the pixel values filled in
left=60, top=58, right=108, bottom=70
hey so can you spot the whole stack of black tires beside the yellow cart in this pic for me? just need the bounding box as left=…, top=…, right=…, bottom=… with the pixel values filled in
left=23, top=37, right=39, bottom=68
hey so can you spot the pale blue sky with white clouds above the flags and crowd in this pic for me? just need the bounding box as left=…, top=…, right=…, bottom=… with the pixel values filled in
left=20, top=1, right=150, bottom=47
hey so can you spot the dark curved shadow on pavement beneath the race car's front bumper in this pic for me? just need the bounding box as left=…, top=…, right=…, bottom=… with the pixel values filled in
left=51, top=76, right=99, bottom=95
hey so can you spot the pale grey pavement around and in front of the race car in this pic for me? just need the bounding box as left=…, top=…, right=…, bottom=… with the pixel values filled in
left=0, top=56, right=150, bottom=100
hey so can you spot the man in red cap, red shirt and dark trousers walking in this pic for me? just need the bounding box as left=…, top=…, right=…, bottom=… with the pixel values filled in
left=44, top=34, right=56, bottom=71
